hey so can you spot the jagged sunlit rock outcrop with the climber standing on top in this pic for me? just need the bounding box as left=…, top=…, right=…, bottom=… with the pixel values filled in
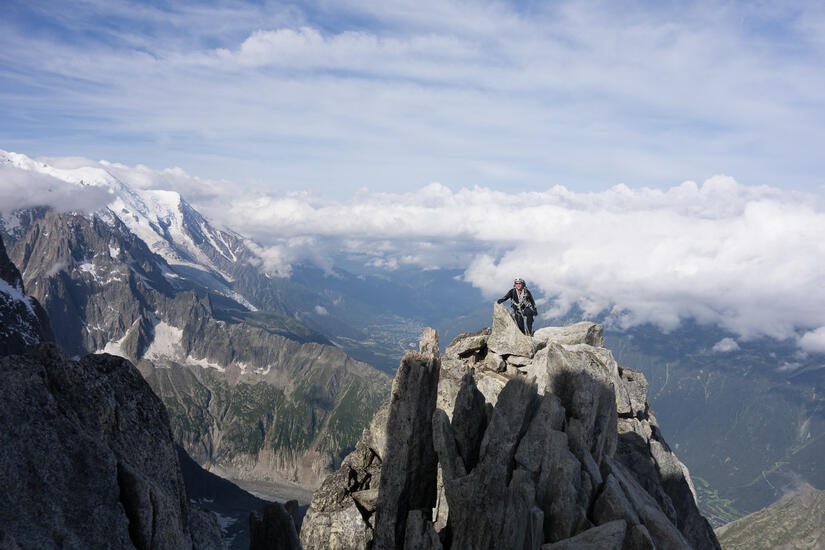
left=301, top=306, right=719, bottom=550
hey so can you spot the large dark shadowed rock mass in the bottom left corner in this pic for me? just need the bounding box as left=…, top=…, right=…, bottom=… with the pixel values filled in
left=0, top=344, right=208, bottom=549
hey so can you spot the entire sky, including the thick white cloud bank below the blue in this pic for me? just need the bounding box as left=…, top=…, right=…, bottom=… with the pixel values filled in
left=0, top=0, right=825, bottom=353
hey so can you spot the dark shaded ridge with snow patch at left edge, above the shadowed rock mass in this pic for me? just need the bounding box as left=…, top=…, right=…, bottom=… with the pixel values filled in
left=0, top=236, right=54, bottom=356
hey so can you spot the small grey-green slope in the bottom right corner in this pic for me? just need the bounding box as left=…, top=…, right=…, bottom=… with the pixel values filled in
left=716, top=484, right=825, bottom=550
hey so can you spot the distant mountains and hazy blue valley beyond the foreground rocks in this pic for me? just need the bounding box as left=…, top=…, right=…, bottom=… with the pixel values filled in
left=0, top=147, right=825, bottom=526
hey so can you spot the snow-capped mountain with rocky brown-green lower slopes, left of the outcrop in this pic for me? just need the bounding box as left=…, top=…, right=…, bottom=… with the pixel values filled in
left=0, top=151, right=389, bottom=492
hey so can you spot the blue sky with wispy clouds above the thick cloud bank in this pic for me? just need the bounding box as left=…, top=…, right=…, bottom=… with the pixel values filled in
left=0, top=0, right=825, bottom=198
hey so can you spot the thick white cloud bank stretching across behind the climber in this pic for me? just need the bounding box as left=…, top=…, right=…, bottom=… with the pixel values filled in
left=0, top=149, right=825, bottom=353
